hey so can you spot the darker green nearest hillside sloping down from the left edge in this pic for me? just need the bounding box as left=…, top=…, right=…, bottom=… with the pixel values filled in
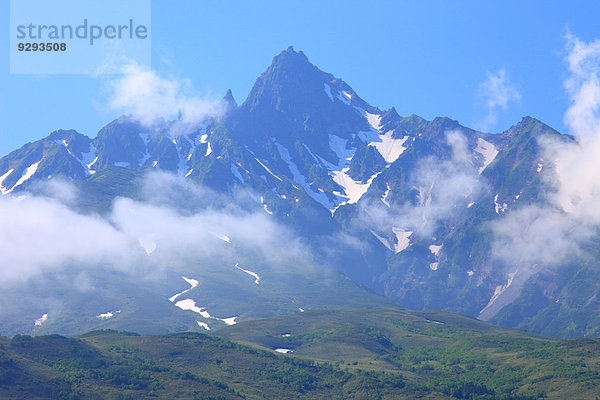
left=0, top=331, right=418, bottom=399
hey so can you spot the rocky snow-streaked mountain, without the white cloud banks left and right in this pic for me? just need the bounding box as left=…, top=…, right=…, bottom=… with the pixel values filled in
left=0, top=47, right=600, bottom=337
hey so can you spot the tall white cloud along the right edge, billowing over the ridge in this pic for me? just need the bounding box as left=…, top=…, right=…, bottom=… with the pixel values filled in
left=493, top=33, right=600, bottom=268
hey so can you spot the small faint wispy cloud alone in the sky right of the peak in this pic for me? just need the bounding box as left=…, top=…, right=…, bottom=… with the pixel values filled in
left=476, top=69, right=521, bottom=131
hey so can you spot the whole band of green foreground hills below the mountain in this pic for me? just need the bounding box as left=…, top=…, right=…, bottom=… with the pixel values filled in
left=0, top=308, right=600, bottom=399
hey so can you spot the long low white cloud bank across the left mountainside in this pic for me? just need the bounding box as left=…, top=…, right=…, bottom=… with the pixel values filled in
left=0, top=173, right=305, bottom=286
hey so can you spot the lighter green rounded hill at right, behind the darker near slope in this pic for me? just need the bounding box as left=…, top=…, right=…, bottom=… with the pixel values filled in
left=218, top=309, right=600, bottom=399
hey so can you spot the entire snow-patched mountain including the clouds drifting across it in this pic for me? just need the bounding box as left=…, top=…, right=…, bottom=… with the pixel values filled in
left=0, top=43, right=600, bottom=337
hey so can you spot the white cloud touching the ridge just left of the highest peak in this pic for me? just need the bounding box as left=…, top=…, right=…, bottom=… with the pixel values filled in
left=109, top=63, right=224, bottom=135
